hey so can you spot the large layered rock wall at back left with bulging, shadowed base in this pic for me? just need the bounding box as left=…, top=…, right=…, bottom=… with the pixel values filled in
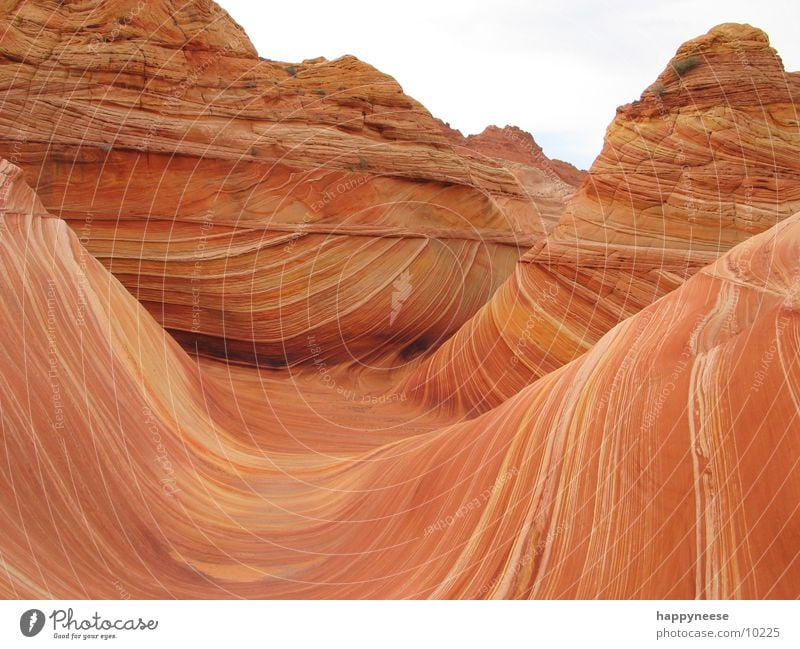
left=0, top=0, right=575, bottom=365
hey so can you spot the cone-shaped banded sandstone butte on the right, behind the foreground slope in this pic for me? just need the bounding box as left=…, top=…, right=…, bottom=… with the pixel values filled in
left=403, top=24, right=800, bottom=413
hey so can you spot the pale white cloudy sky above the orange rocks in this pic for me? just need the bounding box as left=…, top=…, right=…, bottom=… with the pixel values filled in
left=219, top=0, right=800, bottom=168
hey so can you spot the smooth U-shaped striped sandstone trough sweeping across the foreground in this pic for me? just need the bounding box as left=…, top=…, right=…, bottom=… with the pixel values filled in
left=0, top=162, right=800, bottom=599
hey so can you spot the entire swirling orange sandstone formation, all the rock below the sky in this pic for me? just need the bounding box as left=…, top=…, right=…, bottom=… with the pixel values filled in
left=0, top=2, right=800, bottom=599
